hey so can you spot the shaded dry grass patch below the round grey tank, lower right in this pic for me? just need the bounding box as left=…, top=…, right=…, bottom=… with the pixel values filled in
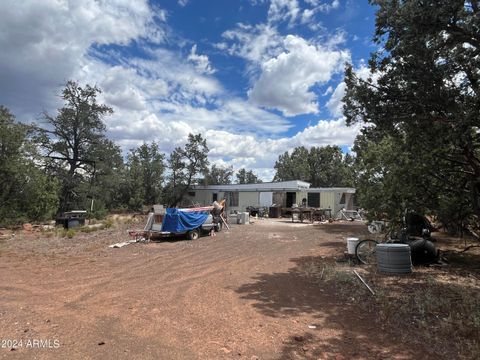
left=300, top=255, right=480, bottom=359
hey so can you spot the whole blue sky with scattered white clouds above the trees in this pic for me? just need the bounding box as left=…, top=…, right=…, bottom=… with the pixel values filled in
left=0, top=0, right=375, bottom=181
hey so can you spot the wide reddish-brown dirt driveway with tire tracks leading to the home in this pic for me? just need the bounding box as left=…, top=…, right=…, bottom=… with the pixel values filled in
left=0, top=219, right=434, bottom=359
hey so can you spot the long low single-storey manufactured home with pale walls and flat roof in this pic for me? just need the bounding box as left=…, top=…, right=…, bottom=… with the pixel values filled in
left=187, top=180, right=355, bottom=214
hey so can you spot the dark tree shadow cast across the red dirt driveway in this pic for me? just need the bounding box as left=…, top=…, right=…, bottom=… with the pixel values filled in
left=236, top=256, right=464, bottom=359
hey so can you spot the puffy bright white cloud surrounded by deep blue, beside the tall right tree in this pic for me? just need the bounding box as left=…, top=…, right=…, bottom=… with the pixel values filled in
left=216, top=0, right=350, bottom=116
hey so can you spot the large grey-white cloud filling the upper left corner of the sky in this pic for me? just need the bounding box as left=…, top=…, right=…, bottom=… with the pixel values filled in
left=0, top=0, right=164, bottom=120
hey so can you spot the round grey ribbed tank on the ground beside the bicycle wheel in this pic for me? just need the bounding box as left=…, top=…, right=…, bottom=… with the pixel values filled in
left=376, top=244, right=412, bottom=275
